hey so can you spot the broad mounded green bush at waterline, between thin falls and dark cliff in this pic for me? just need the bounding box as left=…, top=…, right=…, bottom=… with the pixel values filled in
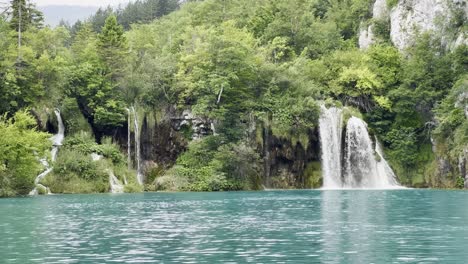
left=155, top=137, right=262, bottom=191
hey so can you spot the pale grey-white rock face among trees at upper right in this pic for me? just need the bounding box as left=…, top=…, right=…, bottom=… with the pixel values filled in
left=359, top=0, right=468, bottom=50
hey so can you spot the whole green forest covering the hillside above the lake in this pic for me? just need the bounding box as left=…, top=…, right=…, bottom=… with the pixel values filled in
left=0, top=0, right=468, bottom=197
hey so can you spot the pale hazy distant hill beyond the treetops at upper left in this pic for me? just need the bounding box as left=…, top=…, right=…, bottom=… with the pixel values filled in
left=38, top=5, right=99, bottom=27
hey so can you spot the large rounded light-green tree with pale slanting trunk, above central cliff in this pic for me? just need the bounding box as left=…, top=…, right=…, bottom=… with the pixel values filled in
left=176, top=21, right=259, bottom=139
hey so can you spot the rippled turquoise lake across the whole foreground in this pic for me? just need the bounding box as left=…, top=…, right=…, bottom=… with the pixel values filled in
left=0, top=190, right=468, bottom=263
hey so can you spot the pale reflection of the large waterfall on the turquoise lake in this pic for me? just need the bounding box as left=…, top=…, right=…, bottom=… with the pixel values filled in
left=322, top=191, right=390, bottom=263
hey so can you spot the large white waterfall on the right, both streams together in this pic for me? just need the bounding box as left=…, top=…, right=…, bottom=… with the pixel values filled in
left=319, top=106, right=400, bottom=189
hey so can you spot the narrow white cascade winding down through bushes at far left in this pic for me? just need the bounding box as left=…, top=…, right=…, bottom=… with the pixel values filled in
left=29, top=109, right=65, bottom=195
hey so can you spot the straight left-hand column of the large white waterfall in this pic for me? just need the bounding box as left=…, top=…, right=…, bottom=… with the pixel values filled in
left=319, top=106, right=343, bottom=189
